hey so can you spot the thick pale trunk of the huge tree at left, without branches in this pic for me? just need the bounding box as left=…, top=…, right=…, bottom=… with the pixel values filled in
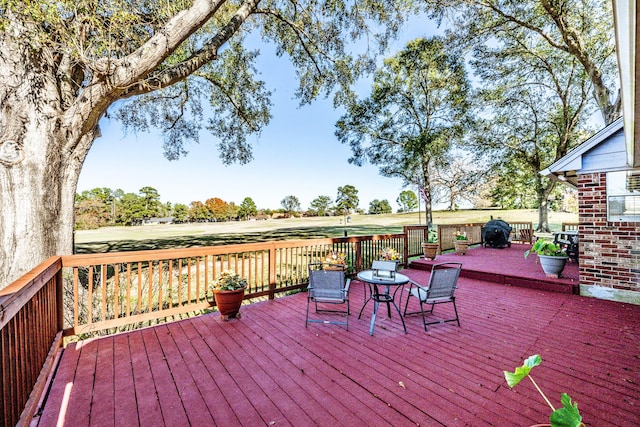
left=0, top=45, right=91, bottom=288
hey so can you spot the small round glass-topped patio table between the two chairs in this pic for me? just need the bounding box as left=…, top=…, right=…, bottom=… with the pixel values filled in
left=358, top=270, right=409, bottom=335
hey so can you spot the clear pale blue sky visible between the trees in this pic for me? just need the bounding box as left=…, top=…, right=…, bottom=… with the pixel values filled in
left=77, top=18, right=436, bottom=211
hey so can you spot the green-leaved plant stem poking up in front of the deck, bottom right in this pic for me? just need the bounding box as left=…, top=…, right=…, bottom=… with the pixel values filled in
left=504, top=354, right=584, bottom=427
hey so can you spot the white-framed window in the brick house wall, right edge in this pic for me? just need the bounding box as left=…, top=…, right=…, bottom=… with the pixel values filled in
left=607, top=170, right=640, bottom=222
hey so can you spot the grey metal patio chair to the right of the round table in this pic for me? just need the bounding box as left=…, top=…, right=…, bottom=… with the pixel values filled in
left=404, top=262, right=462, bottom=331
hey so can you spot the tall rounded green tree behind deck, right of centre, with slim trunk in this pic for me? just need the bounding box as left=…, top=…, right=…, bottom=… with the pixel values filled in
left=336, top=37, right=470, bottom=225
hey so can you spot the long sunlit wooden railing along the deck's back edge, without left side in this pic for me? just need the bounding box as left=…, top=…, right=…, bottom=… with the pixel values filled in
left=62, top=234, right=416, bottom=335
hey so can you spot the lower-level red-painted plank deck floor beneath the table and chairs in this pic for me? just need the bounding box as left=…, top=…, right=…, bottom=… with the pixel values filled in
left=39, top=272, right=640, bottom=427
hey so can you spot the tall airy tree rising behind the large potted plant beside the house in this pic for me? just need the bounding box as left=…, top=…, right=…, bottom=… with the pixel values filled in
left=470, top=18, right=596, bottom=231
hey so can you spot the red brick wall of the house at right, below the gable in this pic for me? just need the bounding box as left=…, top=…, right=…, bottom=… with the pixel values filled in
left=578, top=173, right=640, bottom=291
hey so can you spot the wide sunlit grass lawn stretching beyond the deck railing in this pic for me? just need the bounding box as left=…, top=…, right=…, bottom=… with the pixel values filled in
left=75, top=210, right=578, bottom=253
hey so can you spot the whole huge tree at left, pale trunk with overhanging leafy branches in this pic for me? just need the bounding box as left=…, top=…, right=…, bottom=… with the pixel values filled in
left=0, top=0, right=412, bottom=287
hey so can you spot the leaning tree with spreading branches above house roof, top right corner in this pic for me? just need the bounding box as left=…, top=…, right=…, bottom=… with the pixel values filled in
left=425, top=0, right=622, bottom=124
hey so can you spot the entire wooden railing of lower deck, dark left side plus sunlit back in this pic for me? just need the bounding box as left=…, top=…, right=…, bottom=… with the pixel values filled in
left=0, top=231, right=426, bottom=427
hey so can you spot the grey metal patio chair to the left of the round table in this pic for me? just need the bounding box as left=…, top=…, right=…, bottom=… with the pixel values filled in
left=304, top=263, right=351, bottom=330
